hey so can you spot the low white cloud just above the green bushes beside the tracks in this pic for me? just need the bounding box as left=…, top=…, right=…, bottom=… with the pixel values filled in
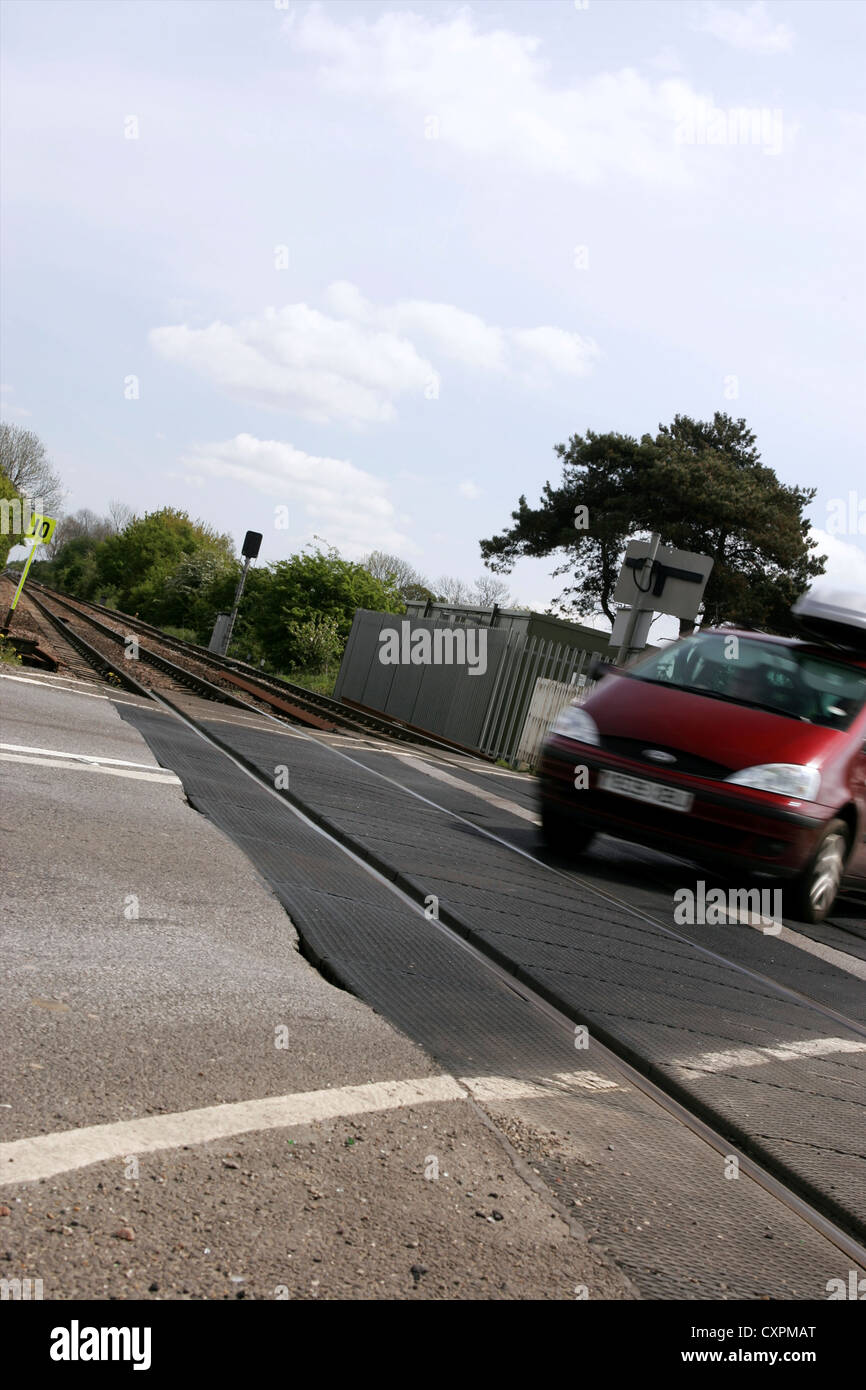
left=181, top=434, right=417, bottom=556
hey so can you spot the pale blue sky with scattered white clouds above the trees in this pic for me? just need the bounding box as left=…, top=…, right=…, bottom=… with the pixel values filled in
left=0, top=0, right=866, bottom=627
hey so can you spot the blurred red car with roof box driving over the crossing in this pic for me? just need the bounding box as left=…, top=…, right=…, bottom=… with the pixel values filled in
left=539, top=589, right=866, bottom=922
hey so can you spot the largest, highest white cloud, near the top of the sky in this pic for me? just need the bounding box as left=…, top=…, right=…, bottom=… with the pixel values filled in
left=285, top=8, right=708, bottom=183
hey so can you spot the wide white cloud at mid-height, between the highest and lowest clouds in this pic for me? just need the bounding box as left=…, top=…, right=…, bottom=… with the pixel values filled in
left=150, top=281, right=599, bottom=425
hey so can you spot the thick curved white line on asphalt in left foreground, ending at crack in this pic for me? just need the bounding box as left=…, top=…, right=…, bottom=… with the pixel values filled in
left=0, top=1076, right=466, bottom=1186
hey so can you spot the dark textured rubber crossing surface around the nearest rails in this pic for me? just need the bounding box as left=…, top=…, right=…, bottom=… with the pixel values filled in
left=121, top=706, right=863, bottom=1298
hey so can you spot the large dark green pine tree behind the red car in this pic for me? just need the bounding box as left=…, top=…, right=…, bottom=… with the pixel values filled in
left=481, top=411, right=824, bottom=631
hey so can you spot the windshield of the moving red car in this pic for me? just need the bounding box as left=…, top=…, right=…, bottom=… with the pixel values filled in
left=627, top=632, right=866, bottom=730
